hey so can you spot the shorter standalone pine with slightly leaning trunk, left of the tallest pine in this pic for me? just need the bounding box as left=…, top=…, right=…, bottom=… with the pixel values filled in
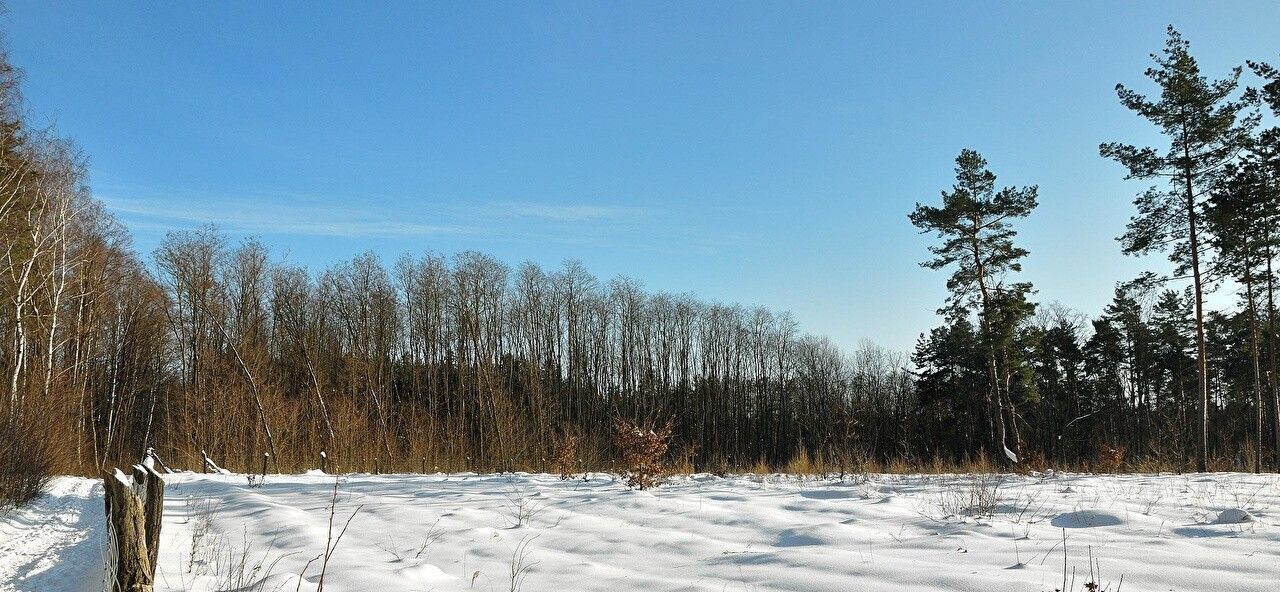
left=910, top=149, right=1037, bottom=463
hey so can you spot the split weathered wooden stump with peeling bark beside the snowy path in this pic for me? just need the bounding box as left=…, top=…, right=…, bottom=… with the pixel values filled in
left=102, top=470, right=163, bottom=592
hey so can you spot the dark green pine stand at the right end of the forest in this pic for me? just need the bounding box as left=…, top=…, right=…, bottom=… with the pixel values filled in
left=911, top=27, right=1280, bottom=470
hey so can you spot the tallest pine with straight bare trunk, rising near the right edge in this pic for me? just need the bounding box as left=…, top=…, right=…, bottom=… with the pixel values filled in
left=1100, top=26, right=1257, bottom=470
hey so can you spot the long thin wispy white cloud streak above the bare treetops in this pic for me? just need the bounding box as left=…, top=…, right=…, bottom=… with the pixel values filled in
left=100, top=188, right=739, bottom=252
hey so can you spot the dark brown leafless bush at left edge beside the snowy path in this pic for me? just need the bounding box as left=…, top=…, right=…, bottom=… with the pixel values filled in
left=0, top=420, right=54, bottom=510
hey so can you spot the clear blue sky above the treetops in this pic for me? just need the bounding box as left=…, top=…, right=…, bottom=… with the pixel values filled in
left=4, top=0, right=1280, bottom=350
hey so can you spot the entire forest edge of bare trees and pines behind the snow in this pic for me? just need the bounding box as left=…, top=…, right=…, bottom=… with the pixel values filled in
left=0, top=29, right=1280, bottom=481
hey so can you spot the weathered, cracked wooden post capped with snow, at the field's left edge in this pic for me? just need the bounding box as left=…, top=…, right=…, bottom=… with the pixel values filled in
left=102, top=465, right=164, bottom=592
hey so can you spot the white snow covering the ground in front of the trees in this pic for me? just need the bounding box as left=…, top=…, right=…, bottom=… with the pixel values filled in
left=0, top=474, right=1280, bottom=592
